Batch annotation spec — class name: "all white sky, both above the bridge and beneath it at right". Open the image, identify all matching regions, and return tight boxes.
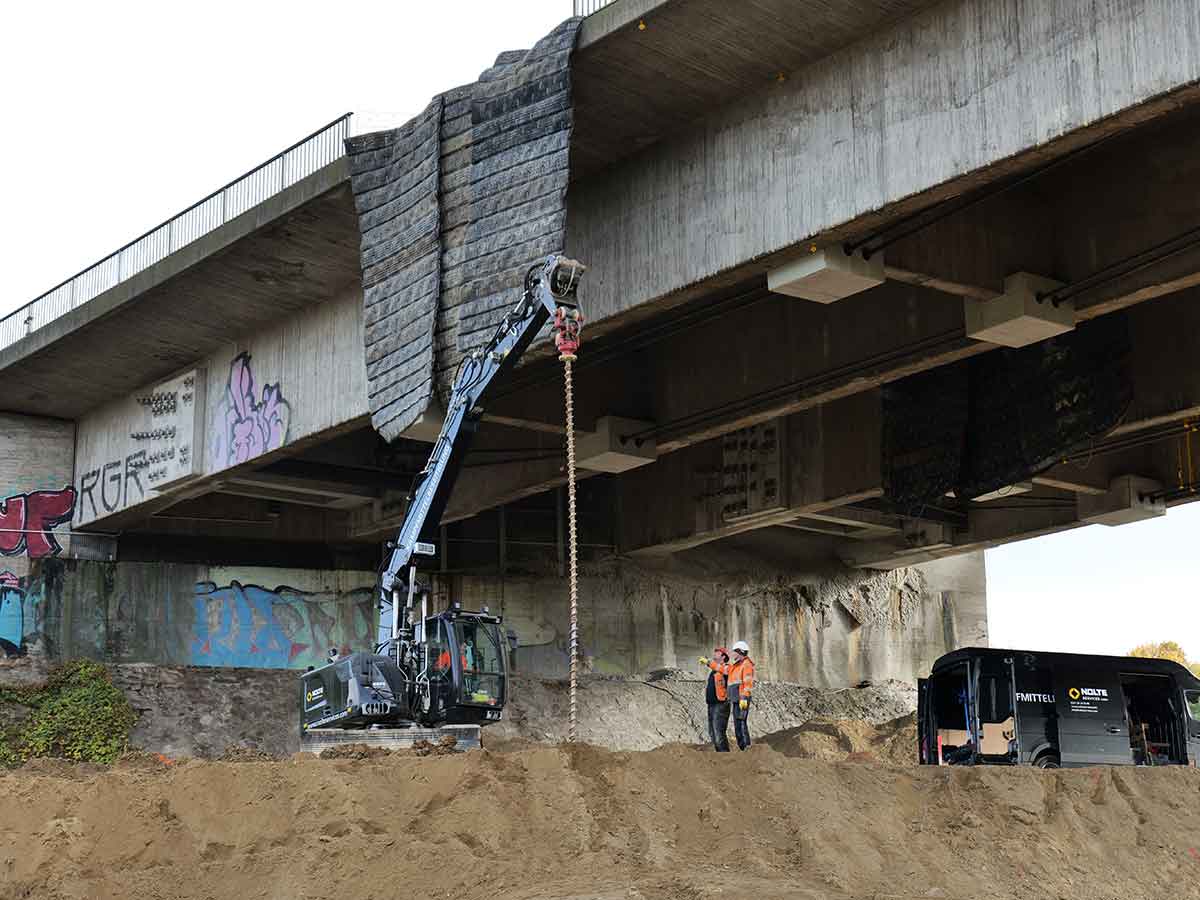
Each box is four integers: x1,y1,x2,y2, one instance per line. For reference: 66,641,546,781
0,0,1200,659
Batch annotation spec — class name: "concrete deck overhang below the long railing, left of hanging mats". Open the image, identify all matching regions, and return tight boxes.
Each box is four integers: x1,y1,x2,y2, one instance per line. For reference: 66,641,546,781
0,160,359,418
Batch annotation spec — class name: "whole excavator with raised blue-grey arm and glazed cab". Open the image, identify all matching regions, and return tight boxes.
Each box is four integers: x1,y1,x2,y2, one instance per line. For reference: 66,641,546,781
300,256,584,749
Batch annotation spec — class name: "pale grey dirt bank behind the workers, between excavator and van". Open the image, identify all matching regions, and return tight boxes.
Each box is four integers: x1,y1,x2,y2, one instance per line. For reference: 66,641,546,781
484,670,917,750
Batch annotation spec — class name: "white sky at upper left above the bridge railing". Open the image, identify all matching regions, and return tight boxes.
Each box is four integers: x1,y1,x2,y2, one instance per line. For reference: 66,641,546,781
0,0,561,313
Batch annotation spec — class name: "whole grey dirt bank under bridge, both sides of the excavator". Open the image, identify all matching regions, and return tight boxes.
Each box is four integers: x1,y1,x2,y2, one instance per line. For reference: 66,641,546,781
79,664,917,760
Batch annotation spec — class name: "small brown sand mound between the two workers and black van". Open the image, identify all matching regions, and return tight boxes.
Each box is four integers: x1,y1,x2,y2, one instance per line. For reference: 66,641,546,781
762,713,917,766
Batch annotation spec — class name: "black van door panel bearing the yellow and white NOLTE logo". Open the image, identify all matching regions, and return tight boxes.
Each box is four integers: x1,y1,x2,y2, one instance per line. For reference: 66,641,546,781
1055,666,1133,767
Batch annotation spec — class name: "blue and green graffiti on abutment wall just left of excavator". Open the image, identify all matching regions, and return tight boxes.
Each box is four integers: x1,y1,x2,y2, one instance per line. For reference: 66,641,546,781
188,581,377,668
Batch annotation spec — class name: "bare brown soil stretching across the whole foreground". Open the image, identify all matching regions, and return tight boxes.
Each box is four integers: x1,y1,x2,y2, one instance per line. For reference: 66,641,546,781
0,748,1200,900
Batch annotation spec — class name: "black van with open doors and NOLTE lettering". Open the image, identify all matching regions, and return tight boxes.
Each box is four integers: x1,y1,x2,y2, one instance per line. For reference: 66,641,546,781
917,647,1200,769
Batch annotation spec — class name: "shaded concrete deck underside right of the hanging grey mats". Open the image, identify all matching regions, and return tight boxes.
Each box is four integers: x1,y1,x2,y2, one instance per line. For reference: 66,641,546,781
571,0,935,178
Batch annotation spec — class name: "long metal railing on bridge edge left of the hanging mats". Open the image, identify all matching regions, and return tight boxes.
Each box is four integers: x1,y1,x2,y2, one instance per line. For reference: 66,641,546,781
0,113,352,349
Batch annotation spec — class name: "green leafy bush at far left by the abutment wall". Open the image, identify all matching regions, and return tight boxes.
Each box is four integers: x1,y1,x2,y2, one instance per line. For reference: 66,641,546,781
0,660,137,768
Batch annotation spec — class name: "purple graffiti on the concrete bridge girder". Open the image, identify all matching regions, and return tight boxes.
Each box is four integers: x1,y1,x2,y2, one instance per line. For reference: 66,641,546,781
216,353,292,466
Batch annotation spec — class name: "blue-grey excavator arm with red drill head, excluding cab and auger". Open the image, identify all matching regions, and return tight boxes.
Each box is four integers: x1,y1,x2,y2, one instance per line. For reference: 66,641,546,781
379,256,584,607
